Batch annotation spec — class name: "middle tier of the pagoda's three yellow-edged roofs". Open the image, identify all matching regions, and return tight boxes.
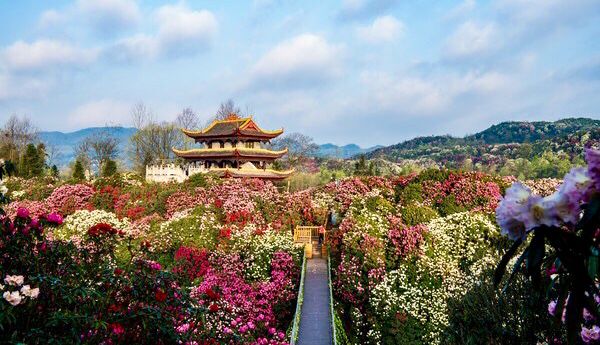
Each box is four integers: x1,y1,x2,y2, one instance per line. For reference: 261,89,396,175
173,147,288,160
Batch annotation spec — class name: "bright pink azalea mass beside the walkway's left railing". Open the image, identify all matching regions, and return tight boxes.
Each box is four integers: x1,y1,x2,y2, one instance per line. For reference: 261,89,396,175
192,253,298,344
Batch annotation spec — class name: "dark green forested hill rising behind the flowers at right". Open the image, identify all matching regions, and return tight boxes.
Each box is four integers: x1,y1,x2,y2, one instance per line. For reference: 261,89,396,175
367,118,600,166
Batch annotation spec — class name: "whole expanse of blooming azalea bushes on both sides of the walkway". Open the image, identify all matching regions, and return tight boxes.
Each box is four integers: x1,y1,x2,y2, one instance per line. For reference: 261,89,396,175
0,165,600,344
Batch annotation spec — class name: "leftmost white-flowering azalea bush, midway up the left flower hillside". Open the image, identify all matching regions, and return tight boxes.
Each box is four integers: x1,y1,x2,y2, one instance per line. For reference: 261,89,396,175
53,210,130,240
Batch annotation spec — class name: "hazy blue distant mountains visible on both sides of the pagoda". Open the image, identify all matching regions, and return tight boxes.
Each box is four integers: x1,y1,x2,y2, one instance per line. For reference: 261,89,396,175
39,127,382,166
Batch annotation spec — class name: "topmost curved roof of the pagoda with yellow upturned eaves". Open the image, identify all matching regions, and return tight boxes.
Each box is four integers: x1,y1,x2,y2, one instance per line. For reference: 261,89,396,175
182,114,283,142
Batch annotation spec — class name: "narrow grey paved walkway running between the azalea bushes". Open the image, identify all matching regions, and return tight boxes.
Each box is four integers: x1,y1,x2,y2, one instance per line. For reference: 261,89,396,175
297,256,333,345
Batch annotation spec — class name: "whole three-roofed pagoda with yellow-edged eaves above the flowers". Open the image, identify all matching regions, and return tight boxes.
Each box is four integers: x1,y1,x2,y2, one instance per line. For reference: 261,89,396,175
173,114,293,180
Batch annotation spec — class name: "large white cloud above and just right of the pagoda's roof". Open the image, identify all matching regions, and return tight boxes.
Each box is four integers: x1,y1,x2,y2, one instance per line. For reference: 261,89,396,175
250,34,342,86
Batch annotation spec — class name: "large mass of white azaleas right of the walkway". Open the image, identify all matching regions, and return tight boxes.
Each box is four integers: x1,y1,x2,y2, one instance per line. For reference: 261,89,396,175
370,212,500,344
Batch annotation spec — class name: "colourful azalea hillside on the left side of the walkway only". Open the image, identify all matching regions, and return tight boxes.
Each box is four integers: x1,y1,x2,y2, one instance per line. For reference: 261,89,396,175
0,175,312,344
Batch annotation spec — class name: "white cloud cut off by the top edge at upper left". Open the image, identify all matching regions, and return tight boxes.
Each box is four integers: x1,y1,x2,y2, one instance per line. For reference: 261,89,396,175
76,0,142,33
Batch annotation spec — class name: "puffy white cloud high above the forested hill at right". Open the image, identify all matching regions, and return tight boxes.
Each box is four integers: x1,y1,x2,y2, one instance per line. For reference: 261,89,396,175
445,21,501,59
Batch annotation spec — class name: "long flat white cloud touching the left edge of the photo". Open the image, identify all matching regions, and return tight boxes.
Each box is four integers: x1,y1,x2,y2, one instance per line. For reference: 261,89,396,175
1,40,97,71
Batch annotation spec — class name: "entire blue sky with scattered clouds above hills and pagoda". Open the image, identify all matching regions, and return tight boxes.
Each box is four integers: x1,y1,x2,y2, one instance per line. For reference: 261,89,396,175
0,0,600,146
